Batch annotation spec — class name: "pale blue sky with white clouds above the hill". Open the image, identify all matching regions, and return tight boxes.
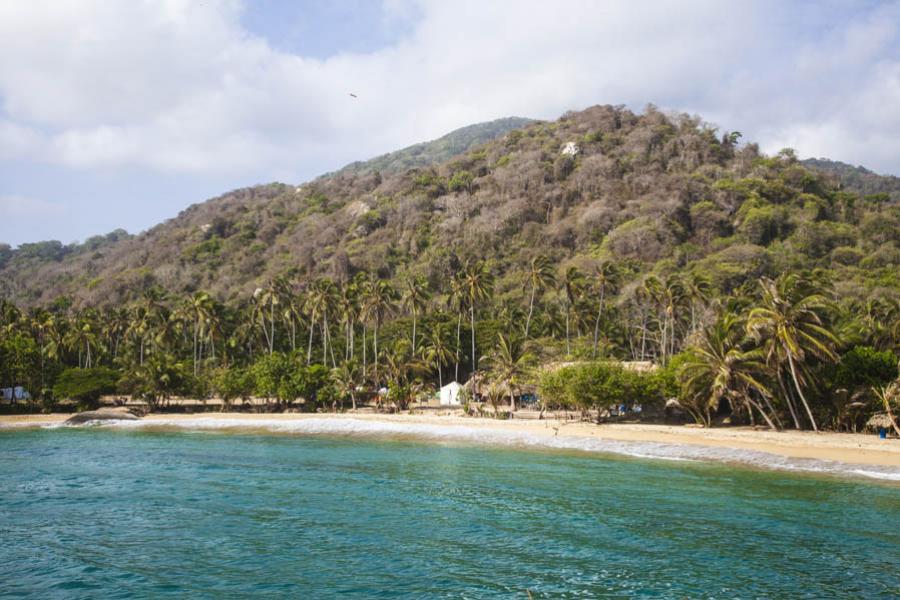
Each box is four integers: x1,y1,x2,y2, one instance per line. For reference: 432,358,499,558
0,0,900,246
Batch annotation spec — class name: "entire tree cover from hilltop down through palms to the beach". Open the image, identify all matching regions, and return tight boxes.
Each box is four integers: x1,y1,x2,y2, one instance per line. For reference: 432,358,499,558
0,106,900,430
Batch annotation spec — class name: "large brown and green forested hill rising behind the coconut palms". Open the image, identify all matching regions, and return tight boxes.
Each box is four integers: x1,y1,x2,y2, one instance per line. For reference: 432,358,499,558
0,106,900,306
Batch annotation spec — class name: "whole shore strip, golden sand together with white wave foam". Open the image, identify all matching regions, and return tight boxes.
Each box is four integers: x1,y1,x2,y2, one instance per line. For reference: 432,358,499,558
7,413,900,481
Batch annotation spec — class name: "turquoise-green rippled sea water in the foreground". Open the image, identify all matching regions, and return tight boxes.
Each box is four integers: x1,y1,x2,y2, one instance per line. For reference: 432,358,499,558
0,427,900,598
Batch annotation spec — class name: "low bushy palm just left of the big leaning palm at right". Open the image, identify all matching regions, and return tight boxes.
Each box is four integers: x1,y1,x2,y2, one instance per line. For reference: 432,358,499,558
679,313,781,429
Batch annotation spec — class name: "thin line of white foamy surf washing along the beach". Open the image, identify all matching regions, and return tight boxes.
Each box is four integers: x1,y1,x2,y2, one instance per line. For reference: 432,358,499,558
67,417,900,481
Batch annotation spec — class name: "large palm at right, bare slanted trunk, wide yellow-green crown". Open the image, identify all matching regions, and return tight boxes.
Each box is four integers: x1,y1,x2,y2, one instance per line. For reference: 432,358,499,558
747,273,838,431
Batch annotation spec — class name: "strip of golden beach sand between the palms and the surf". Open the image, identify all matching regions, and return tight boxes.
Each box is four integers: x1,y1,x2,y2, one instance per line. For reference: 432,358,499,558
7,413,900,472
